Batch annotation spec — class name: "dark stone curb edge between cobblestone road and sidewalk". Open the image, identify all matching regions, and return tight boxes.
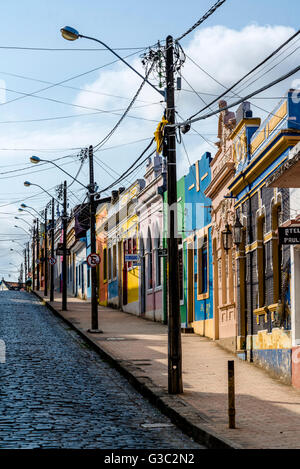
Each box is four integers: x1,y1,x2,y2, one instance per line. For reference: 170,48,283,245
31,291,243,449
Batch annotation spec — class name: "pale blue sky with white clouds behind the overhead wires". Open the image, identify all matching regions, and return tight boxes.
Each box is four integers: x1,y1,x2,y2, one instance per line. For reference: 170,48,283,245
0,0,300,279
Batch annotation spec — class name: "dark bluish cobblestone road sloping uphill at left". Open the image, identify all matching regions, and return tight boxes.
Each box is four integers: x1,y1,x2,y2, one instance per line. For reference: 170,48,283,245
0,291,201,449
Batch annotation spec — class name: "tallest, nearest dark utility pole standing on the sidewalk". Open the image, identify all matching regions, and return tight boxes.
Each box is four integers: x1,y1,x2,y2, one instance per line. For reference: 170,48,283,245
166,36,183,394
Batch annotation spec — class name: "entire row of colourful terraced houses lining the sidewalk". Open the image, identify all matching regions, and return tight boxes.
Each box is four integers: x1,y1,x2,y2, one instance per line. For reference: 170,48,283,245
36,90,300,387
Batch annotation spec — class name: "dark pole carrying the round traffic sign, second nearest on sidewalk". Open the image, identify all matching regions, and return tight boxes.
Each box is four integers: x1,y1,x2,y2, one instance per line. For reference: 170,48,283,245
89,145,102,333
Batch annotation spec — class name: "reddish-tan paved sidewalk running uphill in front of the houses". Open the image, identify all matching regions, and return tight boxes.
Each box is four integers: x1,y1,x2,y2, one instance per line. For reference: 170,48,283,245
34,292,300,448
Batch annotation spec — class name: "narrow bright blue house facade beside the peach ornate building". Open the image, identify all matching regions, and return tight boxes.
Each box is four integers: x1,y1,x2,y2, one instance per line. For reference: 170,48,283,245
183,152,213,338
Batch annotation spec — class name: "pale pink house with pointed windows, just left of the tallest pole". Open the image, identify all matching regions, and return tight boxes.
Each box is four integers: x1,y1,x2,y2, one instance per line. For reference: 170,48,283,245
136,155,166,322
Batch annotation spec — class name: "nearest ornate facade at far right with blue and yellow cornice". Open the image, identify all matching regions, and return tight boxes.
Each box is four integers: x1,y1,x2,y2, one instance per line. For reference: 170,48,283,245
229,91,300,383
